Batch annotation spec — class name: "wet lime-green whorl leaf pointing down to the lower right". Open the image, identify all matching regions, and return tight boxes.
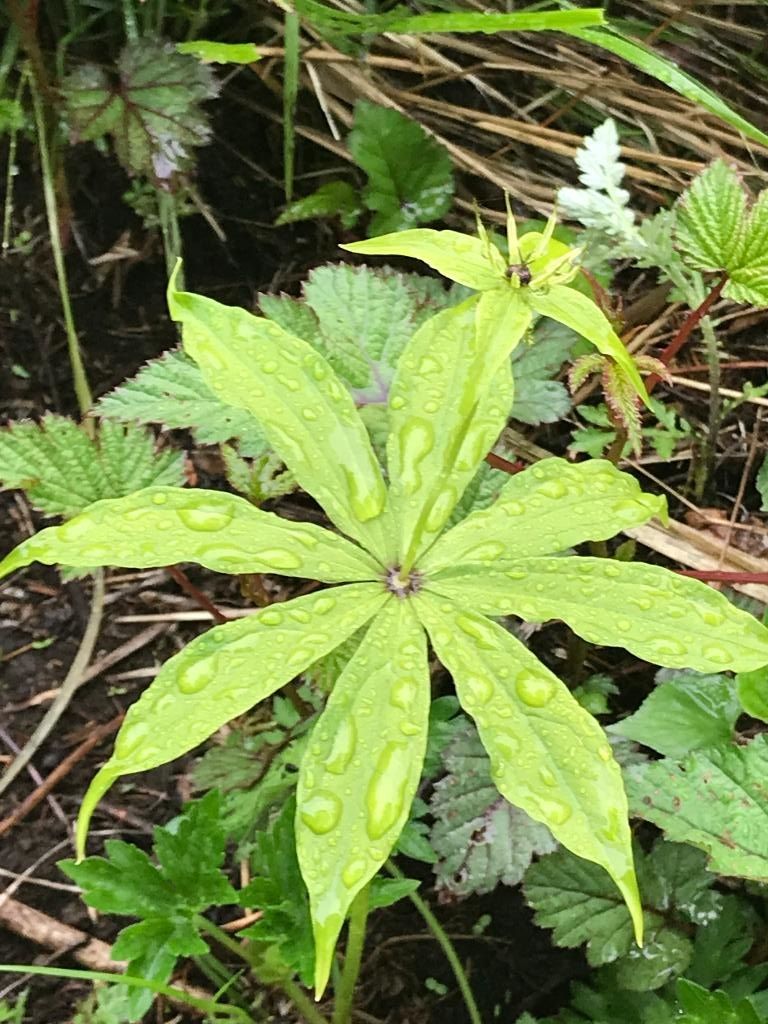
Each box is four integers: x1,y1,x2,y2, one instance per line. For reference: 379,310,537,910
414,592,642,941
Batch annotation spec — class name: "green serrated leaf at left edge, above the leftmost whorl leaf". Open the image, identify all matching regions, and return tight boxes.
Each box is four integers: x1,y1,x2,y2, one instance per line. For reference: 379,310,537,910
0,415,184,520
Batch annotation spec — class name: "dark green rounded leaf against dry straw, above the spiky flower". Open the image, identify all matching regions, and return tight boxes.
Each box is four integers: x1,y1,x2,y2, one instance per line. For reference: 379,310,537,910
347,100,454,236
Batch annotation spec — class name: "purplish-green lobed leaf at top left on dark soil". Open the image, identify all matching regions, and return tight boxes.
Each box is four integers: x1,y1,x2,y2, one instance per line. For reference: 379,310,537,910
61,38,218,182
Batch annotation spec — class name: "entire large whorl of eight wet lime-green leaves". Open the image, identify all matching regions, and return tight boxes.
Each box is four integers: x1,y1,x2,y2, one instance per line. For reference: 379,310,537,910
0,266,768,992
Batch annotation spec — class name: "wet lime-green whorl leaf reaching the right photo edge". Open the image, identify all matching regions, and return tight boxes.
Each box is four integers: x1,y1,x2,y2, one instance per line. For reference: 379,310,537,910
430,557,768,672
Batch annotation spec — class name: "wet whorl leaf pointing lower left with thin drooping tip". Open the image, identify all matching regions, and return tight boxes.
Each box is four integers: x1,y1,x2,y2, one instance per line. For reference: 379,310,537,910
77,584,387,856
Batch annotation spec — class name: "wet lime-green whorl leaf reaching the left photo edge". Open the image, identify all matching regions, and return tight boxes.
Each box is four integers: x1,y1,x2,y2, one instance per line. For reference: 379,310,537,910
0,487,381,583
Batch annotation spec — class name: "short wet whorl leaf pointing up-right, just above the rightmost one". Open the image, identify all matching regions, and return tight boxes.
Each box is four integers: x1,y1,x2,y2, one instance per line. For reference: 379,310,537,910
421,459,667,574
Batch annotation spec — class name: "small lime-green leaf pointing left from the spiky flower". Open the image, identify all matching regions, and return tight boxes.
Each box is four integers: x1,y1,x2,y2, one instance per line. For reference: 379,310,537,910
341,227,507,292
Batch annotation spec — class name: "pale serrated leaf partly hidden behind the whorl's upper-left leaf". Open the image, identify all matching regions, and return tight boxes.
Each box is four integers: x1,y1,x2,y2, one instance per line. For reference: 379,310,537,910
96,350,266,456
